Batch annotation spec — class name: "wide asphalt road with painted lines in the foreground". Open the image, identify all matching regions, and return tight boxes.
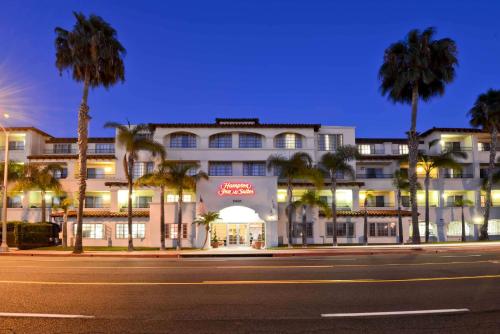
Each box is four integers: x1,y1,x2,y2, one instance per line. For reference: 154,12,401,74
0,252,500,334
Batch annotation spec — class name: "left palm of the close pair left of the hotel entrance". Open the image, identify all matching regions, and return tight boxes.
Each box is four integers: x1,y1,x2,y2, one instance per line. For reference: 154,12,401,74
135,156,170,250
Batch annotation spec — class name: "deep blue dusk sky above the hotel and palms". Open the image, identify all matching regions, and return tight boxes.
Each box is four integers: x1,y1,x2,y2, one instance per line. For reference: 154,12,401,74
0,0,500,137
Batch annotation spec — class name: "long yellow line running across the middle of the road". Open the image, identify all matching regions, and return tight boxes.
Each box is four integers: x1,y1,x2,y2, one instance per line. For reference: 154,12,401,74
0,274,500,286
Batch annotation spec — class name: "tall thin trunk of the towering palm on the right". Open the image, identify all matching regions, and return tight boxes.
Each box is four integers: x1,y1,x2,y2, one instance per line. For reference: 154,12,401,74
408,84,420,244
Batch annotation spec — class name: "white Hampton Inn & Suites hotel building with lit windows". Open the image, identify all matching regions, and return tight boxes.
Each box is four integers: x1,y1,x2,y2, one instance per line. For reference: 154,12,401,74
0,118,500,247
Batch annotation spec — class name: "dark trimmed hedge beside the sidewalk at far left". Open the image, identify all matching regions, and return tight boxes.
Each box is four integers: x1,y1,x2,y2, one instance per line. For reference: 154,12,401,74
0,222,59,249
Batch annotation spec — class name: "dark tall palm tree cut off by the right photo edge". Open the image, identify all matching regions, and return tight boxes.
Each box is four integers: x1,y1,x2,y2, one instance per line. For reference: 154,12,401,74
469,89,500,240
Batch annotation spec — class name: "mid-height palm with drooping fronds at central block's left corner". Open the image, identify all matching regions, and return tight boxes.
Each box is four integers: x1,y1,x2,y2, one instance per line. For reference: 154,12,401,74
104,122,165,252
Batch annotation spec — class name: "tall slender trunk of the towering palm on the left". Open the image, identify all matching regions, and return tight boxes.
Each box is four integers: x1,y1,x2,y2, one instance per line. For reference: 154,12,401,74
73,74,90,254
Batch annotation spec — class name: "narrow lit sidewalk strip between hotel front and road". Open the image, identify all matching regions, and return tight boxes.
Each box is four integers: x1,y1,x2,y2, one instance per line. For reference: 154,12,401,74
0,242,500,258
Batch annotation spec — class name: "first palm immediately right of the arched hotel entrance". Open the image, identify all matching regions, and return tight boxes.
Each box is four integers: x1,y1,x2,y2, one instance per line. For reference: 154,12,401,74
267,152,312,247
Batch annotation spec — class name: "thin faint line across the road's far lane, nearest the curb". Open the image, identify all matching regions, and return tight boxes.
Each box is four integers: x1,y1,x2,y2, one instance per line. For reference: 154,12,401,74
0,260,500,270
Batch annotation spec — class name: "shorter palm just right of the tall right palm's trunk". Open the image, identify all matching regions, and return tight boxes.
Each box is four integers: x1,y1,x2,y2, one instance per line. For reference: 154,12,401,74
418,140,467,243
